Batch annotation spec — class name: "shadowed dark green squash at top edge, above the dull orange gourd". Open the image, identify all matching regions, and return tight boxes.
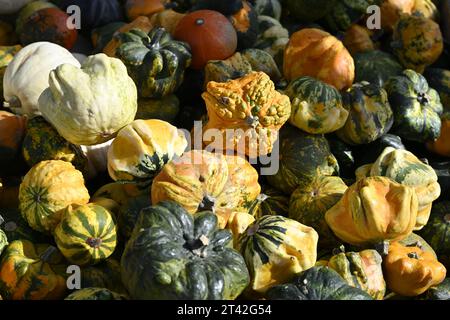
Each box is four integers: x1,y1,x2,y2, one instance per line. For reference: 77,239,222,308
325,0,382,32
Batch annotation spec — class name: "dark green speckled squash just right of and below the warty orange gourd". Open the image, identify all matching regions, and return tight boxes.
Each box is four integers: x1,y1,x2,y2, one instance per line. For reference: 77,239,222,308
267,125,339,195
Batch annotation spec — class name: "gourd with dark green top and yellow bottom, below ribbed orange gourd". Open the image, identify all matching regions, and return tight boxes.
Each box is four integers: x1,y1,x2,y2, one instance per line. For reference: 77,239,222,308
285,77,348,134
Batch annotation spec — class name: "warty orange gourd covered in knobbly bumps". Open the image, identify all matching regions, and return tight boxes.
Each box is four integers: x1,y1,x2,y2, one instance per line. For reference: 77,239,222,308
196,72,291,158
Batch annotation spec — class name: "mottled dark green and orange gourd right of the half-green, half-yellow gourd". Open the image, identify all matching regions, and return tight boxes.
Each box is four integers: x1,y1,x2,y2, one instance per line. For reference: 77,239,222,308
336,82,394,145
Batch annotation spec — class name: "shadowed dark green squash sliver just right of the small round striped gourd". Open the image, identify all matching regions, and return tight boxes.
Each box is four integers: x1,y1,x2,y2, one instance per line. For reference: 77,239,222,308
118,194,152,239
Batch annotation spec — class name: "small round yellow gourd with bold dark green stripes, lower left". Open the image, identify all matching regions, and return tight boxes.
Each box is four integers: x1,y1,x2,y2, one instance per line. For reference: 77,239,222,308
55,204,117,265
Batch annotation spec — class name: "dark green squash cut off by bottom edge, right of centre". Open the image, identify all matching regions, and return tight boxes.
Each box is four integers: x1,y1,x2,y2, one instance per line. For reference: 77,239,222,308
266,266,372,300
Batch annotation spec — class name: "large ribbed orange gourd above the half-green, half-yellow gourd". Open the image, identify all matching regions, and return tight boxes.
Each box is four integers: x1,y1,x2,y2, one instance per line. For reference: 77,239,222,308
283,28,355,90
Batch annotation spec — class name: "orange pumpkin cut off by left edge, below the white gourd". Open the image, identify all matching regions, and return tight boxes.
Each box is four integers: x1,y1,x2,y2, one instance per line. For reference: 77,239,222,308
0,111,27,162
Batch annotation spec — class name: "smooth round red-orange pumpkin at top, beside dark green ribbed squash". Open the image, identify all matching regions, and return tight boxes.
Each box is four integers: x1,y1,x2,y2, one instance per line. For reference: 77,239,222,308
174,10,238,70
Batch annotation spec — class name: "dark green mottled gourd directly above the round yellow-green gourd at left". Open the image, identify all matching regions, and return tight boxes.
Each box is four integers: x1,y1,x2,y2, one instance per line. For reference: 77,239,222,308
22,116,87,172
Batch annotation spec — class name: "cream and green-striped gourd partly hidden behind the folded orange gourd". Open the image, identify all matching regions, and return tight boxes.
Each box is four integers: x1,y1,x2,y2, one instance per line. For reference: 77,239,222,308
358,147,441,230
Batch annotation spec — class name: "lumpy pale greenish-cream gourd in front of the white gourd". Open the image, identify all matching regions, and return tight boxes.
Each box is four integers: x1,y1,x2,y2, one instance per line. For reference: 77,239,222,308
39,53,137,145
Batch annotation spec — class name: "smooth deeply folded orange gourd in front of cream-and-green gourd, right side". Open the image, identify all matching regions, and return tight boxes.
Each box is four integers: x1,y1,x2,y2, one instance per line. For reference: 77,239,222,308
325,177,418,246
